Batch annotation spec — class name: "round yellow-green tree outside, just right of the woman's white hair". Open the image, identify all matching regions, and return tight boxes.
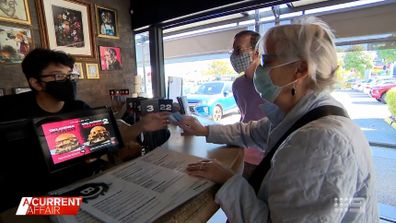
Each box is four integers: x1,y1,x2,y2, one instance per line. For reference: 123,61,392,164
344,46,374,78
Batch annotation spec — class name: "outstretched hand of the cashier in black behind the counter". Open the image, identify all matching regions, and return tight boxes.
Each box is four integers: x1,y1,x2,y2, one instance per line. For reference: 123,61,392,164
138,112,170,132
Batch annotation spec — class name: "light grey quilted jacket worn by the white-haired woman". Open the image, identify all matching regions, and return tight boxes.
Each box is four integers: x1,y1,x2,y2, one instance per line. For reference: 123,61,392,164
207,92,379,223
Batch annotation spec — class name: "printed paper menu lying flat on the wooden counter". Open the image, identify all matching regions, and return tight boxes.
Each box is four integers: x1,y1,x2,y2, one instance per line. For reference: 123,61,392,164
53,148,214,222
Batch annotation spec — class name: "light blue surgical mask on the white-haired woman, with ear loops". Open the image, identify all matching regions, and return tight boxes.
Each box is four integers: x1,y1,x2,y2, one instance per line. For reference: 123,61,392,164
253,60,298,102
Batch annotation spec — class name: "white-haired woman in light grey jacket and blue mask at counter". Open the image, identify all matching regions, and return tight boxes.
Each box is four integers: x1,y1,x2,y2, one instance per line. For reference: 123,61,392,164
178,17,379,223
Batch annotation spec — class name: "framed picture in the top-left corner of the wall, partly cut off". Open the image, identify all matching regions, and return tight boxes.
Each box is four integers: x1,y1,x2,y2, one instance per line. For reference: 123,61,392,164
0,0,30,25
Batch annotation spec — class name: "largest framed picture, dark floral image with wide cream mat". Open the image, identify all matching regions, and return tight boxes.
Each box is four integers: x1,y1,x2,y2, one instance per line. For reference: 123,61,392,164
38,0,95,58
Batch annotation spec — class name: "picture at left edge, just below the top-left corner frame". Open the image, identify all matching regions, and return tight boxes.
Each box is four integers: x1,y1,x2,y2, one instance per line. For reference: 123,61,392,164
0,25,33,64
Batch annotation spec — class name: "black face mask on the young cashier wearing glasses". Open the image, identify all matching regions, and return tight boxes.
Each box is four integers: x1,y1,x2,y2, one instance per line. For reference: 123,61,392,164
45,80,77,101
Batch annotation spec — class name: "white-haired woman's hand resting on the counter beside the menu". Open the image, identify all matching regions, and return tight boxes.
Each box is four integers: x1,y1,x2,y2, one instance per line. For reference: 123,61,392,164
187,160,234,184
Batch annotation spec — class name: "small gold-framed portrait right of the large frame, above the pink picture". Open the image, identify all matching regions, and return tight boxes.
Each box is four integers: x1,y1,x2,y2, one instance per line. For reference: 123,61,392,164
95,5,119,39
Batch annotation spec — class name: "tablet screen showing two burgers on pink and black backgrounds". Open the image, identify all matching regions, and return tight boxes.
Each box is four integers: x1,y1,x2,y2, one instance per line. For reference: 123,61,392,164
34,108,122,170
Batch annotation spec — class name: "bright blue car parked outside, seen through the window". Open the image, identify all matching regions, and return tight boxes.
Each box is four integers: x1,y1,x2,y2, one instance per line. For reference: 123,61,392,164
187,81,237,121
